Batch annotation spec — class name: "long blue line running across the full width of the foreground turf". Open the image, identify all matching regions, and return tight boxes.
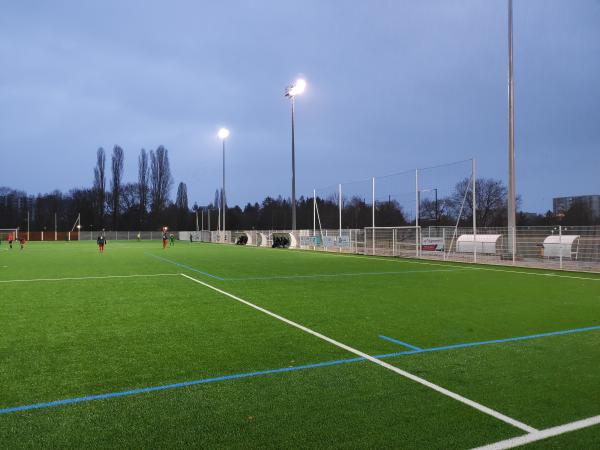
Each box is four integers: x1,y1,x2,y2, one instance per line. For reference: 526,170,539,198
0,325,600,414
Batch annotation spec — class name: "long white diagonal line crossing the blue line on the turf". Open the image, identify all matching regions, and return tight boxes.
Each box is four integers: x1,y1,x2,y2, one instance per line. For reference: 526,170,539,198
181,273,537,433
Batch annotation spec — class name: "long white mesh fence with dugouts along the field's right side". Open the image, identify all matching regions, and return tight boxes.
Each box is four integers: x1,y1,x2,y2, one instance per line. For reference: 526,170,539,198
182,226,600,272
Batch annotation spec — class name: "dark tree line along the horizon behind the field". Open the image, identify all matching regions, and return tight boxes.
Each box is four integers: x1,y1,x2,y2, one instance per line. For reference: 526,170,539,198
0,153,598,231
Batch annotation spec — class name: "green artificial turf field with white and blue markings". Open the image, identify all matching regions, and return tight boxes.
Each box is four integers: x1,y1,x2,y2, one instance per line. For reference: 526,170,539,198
0,241,600,449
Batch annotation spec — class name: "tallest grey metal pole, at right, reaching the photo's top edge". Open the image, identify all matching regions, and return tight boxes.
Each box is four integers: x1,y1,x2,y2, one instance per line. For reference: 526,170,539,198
507,0,517,256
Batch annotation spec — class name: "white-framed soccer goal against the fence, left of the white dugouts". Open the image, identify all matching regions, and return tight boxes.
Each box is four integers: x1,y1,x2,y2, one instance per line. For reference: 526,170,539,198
363,226,421,257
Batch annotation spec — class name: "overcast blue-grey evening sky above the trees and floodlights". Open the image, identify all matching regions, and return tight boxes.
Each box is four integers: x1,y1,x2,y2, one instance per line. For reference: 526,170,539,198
0,0,600,211
